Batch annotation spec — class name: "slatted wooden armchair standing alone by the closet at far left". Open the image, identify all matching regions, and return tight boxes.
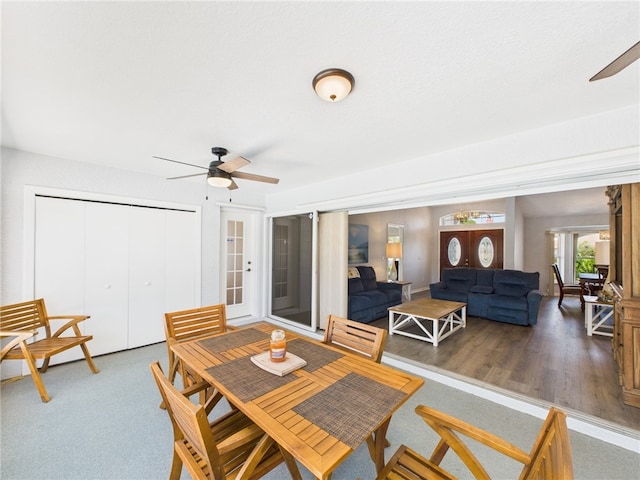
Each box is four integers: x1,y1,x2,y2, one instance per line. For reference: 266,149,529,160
0,298,98,402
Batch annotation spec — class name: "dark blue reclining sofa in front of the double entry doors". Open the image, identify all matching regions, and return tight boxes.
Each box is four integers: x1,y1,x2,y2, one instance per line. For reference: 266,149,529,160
430,267,542,325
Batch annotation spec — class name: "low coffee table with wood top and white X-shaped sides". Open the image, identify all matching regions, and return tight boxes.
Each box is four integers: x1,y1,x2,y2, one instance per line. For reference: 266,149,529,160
388,298,467,347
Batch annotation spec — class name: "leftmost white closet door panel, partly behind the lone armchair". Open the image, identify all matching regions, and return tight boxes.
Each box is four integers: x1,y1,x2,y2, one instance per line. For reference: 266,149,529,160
34,197,86,365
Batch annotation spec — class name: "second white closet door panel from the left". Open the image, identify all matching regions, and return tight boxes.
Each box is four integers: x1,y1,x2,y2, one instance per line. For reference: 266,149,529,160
85,203,130,355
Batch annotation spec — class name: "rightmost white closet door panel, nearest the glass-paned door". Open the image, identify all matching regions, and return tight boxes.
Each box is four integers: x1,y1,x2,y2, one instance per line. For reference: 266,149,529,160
165,210,200,312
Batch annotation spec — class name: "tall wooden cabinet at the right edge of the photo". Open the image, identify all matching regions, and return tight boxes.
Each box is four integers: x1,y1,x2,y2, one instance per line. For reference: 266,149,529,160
607,183,640,407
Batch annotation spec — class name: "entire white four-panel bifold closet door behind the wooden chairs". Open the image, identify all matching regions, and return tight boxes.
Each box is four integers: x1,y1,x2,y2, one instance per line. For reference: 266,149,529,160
35,197,200,364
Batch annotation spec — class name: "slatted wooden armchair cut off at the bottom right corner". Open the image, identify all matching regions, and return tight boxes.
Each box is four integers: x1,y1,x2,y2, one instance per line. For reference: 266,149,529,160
377,405,573,480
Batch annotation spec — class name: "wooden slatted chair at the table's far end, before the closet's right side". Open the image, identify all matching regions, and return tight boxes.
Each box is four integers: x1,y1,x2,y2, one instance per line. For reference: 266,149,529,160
160,304,232,413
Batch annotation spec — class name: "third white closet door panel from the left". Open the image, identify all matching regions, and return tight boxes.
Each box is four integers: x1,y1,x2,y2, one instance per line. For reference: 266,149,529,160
128,207,165,348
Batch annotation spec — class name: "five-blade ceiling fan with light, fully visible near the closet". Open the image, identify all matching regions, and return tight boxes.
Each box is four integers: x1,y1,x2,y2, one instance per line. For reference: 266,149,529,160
153,147,280,190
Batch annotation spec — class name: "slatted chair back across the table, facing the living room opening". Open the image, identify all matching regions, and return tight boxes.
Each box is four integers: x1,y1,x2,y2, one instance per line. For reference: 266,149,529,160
324,315,387,363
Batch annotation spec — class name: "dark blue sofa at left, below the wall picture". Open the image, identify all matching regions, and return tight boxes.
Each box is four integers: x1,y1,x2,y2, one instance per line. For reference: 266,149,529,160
347,266,402,323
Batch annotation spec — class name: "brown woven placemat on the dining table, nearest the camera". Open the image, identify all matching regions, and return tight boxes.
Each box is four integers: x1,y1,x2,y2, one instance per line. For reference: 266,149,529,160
293,373,405,449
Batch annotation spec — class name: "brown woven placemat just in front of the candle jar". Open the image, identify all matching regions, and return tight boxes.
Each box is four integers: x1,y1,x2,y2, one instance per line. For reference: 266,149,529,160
207,356,298,402
